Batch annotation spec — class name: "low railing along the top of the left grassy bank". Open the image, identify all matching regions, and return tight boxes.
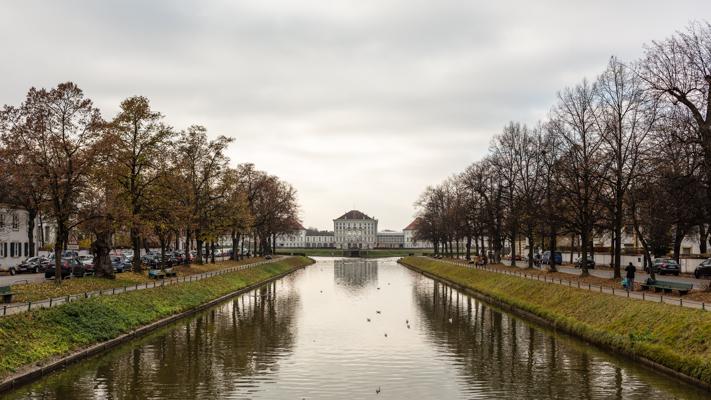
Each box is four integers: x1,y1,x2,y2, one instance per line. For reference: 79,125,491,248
0,256,282,317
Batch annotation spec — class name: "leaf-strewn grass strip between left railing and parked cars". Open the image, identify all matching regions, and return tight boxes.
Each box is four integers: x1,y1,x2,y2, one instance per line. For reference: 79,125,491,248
12,258,264,303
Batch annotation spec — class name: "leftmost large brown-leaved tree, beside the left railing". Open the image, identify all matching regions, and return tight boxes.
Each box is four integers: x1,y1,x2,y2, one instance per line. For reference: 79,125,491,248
2,82,104,284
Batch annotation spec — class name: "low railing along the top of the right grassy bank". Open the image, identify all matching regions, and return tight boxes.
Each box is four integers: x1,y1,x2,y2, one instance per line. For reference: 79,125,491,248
428,260,708,311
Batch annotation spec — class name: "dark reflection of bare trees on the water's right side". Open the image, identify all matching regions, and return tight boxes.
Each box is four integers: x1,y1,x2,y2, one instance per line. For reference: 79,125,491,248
414,279,696,399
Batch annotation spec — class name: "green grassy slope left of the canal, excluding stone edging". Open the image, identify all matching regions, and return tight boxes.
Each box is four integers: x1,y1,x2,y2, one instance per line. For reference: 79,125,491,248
0,257,311,380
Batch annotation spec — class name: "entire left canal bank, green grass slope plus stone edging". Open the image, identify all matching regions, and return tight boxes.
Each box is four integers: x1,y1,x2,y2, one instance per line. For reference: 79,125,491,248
0,257,314,393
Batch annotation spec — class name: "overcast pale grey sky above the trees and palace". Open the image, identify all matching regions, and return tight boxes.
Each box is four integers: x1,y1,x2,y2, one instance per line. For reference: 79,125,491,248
0,0,711,230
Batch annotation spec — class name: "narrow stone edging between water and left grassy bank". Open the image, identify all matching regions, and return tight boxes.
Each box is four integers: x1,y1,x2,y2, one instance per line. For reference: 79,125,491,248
0,257,315,394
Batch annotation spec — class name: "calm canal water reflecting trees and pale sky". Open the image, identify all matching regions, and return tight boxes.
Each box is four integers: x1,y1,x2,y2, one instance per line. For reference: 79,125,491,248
7,259,710,400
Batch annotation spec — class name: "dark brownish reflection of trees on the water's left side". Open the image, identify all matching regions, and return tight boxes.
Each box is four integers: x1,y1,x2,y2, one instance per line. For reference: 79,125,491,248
13,280,299,399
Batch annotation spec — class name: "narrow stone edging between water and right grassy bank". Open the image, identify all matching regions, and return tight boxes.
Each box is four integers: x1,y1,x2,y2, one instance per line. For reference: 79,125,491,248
398,259,711,392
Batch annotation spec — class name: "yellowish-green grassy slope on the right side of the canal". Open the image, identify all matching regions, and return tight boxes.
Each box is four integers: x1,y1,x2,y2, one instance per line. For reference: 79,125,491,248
402,257,711,385
